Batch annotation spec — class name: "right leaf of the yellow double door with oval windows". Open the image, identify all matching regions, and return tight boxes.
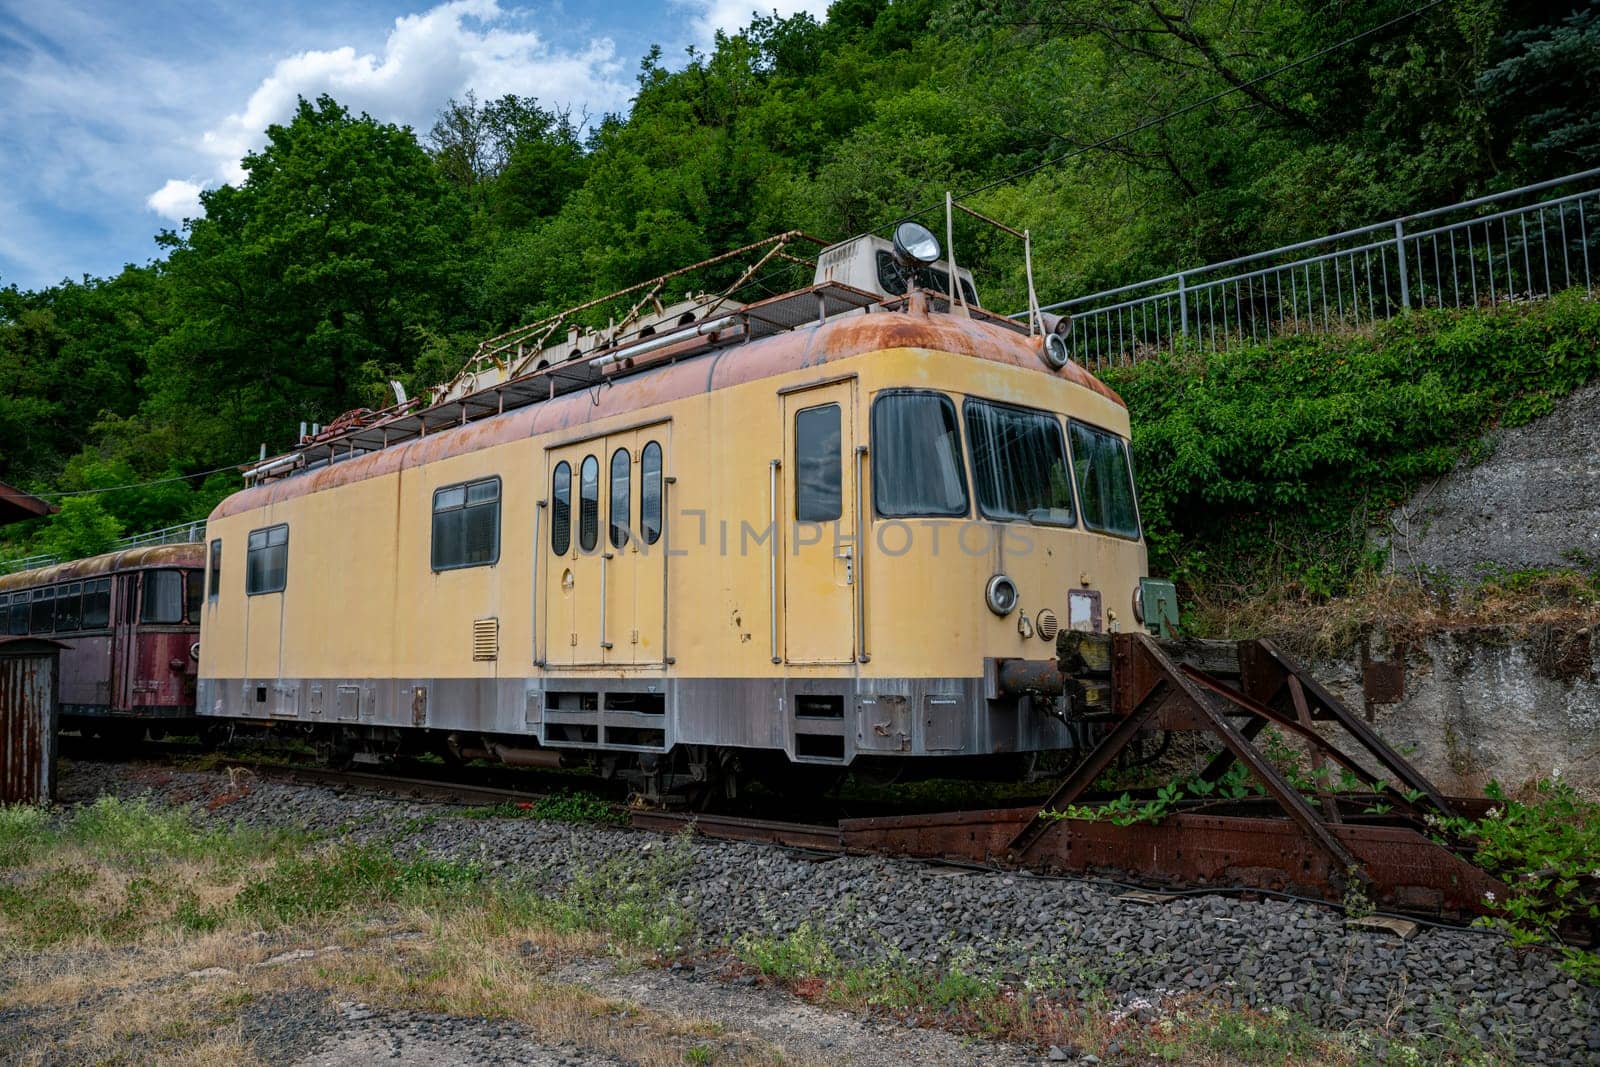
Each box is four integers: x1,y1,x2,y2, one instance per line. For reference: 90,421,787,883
602,424,667,665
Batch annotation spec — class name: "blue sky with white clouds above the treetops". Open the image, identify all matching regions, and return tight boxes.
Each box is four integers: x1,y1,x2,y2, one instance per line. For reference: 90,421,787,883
0,0,827,290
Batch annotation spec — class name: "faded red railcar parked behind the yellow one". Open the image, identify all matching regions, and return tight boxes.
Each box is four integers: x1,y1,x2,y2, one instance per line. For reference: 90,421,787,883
0,544,205,729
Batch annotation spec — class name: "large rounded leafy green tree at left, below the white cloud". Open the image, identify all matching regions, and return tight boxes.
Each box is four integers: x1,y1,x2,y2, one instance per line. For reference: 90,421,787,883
147,96,472,461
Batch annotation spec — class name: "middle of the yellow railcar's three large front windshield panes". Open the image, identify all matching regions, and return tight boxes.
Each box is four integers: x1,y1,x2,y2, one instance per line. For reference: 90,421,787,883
965,400,1075,526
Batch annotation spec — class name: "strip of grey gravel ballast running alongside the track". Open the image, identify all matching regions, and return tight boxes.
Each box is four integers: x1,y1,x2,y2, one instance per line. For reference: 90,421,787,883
64,765,1600,1064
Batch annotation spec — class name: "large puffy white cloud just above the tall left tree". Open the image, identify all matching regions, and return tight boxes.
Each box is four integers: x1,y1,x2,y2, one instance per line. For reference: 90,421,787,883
146,0,629,218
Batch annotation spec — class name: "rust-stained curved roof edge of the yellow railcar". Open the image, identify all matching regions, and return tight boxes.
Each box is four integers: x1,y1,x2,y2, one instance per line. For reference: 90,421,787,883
211,303,1126,518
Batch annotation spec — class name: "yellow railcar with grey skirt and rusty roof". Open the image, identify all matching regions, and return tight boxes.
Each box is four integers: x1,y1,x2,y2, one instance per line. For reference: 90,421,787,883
198,230,1146,792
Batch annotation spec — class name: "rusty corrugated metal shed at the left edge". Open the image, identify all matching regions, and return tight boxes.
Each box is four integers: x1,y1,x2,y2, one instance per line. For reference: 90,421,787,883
0,637,66,805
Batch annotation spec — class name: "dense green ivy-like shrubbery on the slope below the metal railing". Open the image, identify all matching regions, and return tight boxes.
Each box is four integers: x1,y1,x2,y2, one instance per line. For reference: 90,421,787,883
1106,291,1600,600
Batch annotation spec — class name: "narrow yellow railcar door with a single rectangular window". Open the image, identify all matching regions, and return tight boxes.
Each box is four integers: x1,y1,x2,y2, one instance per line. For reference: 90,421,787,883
774,381,859,664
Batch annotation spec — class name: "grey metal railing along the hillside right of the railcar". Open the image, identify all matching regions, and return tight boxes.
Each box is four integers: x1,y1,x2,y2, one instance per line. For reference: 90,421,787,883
1045,168,1600,368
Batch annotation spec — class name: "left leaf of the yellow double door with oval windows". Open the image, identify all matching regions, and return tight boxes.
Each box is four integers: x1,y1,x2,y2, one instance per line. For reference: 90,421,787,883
544,440,610,667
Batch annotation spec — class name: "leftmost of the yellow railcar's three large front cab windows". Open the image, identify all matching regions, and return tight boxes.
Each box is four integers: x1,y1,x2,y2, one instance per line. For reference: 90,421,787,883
872,392,966,518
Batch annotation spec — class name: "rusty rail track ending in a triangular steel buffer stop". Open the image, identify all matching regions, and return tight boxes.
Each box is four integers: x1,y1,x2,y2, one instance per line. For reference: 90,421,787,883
53,632,1561,936
